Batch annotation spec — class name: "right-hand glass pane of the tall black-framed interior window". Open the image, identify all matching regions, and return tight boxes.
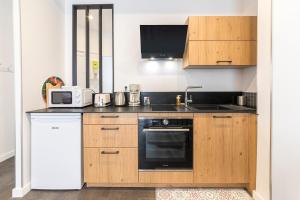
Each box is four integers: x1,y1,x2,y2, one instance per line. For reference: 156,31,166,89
102,9,113,93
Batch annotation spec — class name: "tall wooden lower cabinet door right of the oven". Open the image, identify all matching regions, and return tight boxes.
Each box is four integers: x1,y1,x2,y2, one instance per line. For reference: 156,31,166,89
194,114,248,183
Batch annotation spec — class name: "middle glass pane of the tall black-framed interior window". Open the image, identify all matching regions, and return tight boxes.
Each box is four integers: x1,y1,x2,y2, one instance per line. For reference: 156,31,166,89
88,9,100,93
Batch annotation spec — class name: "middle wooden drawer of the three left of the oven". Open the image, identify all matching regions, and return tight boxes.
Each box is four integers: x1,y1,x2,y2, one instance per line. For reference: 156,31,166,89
83,125,138,147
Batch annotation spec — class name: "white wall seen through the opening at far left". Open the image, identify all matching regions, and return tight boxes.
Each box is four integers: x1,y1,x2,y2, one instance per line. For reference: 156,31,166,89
0,0,15,162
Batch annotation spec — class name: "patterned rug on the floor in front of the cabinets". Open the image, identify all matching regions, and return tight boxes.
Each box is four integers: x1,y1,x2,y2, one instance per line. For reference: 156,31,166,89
155,188,252,200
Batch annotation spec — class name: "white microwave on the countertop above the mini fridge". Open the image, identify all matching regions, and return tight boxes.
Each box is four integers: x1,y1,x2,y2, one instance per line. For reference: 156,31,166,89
47,86,93,108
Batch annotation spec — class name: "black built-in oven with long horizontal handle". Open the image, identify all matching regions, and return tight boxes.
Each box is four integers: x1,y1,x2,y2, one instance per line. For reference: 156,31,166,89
139,118,193,170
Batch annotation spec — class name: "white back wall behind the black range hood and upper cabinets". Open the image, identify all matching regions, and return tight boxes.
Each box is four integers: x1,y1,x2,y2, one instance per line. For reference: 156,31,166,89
66,0,257,91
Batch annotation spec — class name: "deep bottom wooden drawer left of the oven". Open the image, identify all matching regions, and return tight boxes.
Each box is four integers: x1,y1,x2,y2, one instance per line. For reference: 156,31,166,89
84,148,138,183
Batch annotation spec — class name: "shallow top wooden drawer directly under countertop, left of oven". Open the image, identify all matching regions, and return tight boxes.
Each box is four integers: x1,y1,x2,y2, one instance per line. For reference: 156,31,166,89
83,113,137,124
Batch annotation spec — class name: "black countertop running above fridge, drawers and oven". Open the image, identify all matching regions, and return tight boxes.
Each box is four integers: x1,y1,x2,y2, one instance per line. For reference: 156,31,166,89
27,104,256,114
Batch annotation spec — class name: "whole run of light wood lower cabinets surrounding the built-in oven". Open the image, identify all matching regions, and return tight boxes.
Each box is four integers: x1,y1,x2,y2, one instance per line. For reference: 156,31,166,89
84,113,256,192
